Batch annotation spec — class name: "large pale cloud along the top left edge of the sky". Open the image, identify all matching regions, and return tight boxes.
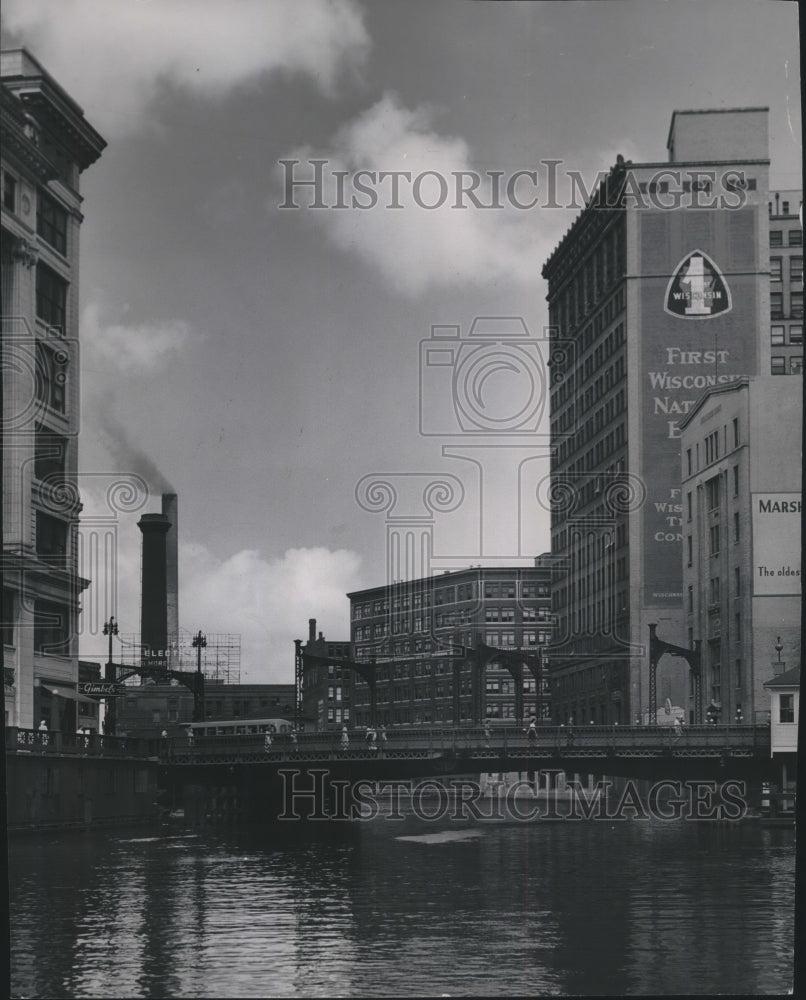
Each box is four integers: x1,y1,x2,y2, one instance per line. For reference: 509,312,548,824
3,0,369,135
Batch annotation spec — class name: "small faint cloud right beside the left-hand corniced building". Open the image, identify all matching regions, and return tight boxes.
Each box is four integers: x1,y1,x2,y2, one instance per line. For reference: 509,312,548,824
81,303,193,375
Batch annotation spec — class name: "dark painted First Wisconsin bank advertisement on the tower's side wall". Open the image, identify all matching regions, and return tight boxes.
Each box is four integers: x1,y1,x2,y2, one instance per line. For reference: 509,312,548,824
631,207,764,607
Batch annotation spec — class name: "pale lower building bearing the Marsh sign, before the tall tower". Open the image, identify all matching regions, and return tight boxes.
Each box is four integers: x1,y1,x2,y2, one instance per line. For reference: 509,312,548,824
681,375,803,723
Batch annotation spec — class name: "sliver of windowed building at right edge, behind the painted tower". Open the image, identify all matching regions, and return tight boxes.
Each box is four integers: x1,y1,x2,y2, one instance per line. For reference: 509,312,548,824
768,191,803,375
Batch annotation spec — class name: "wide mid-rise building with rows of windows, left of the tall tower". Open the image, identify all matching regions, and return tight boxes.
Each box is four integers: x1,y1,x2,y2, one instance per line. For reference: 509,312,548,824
348,556,552,726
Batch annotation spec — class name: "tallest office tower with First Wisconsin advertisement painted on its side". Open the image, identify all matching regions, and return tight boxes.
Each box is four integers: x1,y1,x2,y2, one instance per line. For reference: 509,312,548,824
543,108,770,723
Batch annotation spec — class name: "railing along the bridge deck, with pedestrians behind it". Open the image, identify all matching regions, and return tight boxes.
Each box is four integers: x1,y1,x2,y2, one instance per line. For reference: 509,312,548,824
160,725,769,763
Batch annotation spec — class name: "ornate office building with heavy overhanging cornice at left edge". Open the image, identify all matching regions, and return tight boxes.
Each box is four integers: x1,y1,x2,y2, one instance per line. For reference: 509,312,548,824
0,49,106,731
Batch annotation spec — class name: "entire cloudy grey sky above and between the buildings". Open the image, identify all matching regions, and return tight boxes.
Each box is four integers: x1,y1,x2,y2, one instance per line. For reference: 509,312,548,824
2,0,802,683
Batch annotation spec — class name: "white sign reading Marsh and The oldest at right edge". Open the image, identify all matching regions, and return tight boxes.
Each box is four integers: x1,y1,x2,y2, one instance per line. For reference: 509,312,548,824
752,493,801,597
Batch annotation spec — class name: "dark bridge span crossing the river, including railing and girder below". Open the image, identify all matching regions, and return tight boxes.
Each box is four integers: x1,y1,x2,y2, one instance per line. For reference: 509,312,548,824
160,725,770,784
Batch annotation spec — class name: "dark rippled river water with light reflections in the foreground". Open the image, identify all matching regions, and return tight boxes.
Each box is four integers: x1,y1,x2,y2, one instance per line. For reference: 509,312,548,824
9,817,794,997
